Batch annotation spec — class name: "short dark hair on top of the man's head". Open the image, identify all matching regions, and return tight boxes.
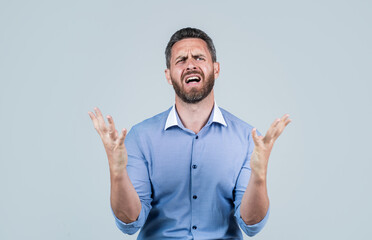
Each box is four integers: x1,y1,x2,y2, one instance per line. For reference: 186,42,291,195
165,27,217,68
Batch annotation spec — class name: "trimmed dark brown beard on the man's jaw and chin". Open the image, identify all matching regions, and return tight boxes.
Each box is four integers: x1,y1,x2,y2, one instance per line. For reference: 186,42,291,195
171,69,215,103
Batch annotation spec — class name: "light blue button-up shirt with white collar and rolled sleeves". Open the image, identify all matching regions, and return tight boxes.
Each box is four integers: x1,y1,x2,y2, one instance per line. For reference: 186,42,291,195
114,103,269,240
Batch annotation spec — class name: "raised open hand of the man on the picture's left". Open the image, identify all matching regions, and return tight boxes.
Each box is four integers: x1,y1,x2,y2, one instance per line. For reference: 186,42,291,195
88,107,128,174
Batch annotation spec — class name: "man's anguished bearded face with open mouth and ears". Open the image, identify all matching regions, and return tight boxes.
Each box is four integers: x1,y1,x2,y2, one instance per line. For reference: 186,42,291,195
165,38,219,103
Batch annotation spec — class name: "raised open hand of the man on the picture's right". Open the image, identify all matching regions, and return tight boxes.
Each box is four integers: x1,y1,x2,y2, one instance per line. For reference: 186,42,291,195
250,114,291,179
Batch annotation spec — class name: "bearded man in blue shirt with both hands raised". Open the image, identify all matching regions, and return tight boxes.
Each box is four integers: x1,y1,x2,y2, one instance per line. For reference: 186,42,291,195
89,28,291,239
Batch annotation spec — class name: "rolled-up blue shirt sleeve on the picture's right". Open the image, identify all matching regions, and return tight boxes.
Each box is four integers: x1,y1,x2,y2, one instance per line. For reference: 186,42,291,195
234,128,270,237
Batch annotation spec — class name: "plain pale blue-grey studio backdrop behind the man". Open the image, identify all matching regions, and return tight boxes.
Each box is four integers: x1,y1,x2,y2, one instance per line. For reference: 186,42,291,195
0,0,372,240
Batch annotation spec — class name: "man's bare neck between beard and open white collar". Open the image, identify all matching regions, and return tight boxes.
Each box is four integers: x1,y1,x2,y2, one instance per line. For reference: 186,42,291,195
176,90,214,134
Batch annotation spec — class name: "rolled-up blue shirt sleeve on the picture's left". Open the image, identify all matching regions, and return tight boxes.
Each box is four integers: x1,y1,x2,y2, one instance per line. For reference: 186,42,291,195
111,127,152,235
